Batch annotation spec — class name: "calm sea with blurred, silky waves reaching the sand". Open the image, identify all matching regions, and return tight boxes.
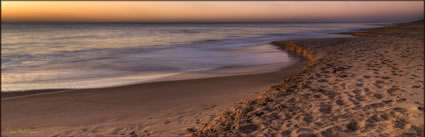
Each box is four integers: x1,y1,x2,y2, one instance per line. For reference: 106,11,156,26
1,23,388,92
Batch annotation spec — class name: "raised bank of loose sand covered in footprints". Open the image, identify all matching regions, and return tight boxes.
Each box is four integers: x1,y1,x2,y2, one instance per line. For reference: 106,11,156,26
192,21,424,137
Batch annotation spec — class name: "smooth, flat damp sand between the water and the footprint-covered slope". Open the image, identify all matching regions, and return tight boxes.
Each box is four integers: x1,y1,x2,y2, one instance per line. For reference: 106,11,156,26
1,57,308,137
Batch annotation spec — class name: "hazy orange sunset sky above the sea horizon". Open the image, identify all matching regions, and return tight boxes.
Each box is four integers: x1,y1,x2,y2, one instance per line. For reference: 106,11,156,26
1,1,424,22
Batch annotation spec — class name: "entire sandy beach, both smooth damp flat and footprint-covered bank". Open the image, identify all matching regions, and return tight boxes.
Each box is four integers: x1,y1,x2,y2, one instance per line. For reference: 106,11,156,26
1,21,424,137
